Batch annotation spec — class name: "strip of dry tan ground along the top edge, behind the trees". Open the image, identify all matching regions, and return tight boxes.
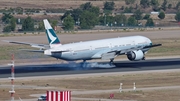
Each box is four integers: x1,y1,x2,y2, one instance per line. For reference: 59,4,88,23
0,0,179,9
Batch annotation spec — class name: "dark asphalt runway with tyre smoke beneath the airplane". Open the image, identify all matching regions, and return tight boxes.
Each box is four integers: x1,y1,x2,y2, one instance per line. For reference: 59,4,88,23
0,58,180,78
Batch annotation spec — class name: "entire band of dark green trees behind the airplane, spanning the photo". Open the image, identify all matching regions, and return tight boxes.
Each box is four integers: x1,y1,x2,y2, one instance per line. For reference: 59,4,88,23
2,2,180,32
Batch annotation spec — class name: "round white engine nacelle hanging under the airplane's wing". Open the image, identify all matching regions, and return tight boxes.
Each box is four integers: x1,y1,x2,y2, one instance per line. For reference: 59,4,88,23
127,50,144,61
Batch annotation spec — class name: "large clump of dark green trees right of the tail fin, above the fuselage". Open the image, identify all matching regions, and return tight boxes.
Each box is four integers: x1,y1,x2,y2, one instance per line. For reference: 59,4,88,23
61,2,171,30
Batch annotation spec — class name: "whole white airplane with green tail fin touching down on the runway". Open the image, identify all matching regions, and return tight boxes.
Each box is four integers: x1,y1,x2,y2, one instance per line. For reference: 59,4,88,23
3,19,162,64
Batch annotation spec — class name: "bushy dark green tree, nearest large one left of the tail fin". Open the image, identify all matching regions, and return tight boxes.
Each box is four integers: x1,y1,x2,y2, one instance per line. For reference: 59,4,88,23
22,16,34,31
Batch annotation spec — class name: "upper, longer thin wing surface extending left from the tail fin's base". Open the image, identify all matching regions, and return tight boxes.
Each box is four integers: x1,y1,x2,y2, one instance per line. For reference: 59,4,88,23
3,40,50,49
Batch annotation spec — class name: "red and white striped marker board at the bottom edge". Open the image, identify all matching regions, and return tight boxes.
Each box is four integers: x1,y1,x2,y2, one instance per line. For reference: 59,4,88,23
46,91,71,101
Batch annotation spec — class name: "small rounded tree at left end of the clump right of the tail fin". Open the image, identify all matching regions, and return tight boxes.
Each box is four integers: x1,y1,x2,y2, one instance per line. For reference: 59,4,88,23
63,15,74,30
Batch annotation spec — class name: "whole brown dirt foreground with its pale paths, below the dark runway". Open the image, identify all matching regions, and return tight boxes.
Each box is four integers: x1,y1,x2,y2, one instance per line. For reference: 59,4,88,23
0,70,180,101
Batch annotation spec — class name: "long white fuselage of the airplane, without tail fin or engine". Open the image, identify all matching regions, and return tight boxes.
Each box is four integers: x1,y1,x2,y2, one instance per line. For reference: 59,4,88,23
44,36,152,61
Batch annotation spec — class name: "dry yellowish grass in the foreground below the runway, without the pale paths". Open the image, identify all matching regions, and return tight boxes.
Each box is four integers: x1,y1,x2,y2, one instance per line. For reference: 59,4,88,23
0,72,180,101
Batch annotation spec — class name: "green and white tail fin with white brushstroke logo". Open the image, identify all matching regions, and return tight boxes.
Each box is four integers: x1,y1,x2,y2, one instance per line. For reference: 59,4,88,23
43,19,60,47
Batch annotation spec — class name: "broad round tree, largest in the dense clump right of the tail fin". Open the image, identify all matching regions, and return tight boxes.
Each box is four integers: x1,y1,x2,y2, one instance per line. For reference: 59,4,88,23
80,10,98,29
